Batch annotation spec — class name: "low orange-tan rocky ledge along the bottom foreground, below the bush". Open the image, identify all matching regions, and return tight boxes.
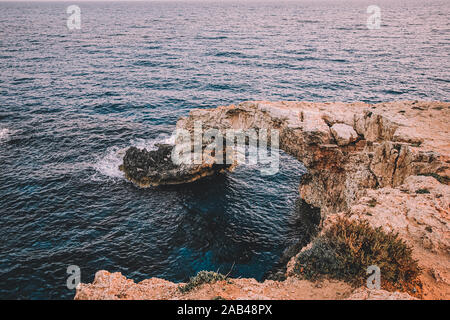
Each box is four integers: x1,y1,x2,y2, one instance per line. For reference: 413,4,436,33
75,271,415,300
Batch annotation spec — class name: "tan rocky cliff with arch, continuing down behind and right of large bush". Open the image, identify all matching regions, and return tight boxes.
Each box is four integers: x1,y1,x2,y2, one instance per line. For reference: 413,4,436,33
76,101,450,298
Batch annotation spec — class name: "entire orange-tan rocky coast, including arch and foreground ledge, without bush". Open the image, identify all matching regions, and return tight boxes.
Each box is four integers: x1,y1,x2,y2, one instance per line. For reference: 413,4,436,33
75,101,450,299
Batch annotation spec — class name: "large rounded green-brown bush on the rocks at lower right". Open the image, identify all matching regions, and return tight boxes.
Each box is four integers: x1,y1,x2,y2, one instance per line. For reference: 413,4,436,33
294,217,421,295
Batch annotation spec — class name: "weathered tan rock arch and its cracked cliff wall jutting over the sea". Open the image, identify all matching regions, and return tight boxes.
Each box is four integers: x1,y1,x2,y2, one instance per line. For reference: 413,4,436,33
177,102,450,216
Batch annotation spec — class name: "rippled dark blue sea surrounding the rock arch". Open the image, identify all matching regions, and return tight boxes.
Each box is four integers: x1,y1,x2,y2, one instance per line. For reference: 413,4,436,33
0,0,450,299
